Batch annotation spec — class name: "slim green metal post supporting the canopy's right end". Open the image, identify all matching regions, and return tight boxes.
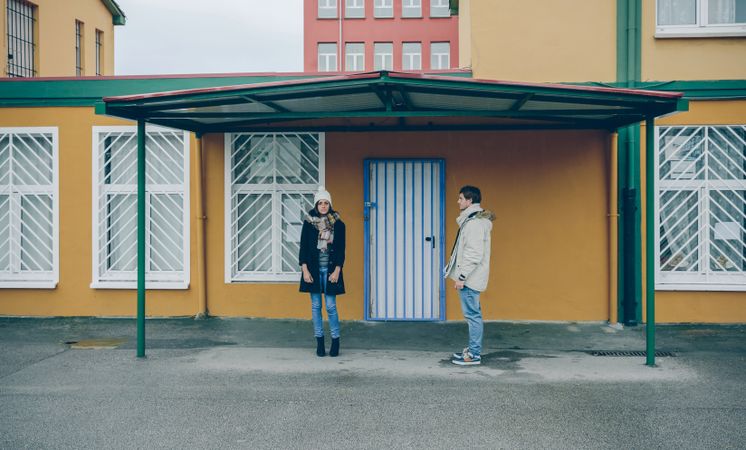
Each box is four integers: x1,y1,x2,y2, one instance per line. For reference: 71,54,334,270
645,117,656,366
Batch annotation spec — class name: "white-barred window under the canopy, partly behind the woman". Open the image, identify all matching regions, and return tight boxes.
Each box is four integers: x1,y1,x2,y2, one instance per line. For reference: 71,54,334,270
225,133,324,283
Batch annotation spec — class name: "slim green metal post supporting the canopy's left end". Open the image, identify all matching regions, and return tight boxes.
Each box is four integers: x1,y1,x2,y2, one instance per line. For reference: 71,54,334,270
137,120,145,358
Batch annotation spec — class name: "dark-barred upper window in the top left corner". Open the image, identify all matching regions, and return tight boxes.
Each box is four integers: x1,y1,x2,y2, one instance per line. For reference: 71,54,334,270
6,0,36,77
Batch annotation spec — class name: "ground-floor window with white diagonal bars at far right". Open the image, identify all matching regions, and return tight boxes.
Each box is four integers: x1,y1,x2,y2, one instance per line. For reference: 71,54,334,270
656,125,746,291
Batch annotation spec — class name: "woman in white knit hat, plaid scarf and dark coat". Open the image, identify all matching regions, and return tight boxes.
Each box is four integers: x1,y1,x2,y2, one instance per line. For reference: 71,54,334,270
298,186,345,356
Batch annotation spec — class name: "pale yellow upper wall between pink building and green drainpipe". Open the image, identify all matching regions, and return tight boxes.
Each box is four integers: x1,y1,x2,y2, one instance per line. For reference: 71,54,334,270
459,0,616,81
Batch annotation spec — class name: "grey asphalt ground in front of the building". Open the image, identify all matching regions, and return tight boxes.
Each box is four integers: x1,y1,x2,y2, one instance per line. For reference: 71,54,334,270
0,318,746,449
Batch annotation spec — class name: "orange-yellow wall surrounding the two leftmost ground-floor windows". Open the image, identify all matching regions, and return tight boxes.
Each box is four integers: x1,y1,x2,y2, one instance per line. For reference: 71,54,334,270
0,108,197,316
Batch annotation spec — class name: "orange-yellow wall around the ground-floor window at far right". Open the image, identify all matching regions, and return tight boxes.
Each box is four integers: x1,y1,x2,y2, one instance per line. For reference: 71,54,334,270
640,100,746,323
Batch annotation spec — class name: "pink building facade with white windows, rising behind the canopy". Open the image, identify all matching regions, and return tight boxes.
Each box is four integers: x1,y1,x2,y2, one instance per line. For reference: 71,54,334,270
303,0,458,72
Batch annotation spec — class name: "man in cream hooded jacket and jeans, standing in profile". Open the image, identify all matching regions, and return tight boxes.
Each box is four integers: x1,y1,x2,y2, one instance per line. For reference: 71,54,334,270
444,186,495,366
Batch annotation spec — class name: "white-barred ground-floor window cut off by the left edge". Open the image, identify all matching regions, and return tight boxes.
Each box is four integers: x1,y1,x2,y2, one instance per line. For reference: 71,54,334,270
0,128,60,288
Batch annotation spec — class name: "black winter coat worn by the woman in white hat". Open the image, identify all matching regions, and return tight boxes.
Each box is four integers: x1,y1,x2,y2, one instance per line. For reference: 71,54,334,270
298,209,345,295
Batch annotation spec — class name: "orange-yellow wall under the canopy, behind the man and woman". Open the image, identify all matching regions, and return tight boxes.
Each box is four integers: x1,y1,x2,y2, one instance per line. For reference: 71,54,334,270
199,128,608,320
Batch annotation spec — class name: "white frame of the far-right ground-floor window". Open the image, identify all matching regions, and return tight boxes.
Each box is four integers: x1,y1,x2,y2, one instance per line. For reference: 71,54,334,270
654,124,746,292
